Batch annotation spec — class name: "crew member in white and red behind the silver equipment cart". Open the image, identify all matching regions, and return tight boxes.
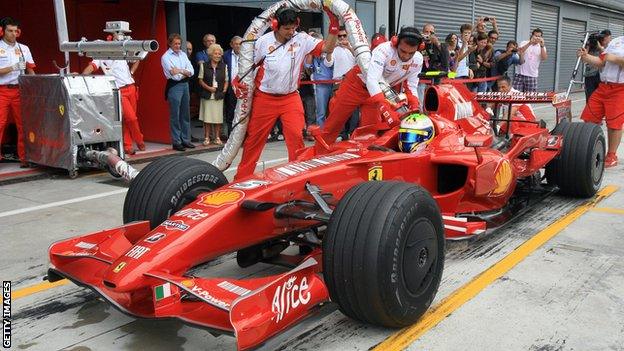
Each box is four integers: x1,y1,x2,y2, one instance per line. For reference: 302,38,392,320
82,26,145,155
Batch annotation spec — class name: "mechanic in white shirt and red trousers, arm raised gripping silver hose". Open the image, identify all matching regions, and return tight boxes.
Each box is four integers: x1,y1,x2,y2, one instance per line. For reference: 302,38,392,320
232,8,339,179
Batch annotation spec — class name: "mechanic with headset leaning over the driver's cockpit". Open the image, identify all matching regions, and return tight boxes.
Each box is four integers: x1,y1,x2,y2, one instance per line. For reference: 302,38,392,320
323,27,423,144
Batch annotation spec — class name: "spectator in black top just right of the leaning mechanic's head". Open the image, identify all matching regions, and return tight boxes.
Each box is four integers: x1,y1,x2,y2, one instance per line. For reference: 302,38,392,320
418,23,449,103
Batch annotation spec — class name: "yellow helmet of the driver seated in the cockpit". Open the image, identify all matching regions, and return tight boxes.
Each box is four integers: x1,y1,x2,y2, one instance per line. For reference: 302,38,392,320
399,113,435,153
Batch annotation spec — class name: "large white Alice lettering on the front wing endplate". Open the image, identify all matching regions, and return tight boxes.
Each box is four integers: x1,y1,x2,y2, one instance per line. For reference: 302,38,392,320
271,276,311,323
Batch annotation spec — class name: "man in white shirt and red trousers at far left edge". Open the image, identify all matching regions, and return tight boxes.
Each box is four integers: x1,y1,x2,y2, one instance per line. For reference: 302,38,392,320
0,17,35,168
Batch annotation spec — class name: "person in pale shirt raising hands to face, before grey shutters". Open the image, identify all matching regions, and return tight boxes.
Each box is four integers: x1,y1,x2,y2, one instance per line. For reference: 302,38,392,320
513,28,548,92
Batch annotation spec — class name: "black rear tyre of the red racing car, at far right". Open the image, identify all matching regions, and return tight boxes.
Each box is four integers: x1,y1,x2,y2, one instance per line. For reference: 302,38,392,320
546,121,605,198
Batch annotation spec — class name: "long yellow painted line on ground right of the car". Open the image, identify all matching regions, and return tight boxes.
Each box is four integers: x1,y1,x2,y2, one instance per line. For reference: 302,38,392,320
373,185,618,351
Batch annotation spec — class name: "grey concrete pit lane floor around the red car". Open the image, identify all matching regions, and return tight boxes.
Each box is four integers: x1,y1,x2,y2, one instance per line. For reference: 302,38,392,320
0,95,624,350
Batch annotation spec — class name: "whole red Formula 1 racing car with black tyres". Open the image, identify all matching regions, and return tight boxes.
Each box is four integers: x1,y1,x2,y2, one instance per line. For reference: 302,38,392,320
48,76,605,349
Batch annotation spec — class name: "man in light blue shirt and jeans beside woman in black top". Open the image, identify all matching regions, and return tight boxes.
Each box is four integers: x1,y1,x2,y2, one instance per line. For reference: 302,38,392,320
160,33,195,151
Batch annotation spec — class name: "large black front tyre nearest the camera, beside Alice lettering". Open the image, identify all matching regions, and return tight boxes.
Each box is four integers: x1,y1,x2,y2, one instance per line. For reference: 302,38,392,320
323,182,444,328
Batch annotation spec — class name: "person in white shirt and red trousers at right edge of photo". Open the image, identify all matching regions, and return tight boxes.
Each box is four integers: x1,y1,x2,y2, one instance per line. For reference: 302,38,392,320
577,36,624,167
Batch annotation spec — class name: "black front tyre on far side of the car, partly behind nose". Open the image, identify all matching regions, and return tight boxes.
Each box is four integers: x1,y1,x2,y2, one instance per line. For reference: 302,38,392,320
123,156,227,229
